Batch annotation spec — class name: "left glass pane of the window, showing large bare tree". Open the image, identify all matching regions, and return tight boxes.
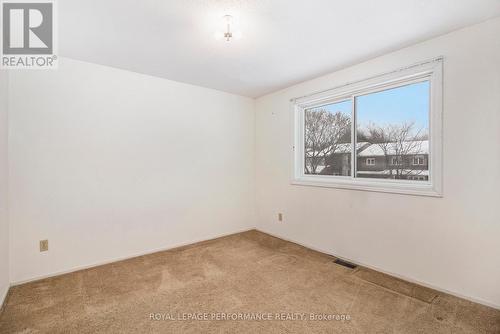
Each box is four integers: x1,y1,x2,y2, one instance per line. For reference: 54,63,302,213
304,100,352,176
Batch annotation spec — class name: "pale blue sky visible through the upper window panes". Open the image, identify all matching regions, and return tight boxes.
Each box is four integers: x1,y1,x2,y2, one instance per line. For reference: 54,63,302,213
322,81,430,129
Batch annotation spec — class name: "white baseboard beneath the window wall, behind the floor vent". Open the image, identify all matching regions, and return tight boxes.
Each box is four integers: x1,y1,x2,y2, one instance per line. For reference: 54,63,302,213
256,228,500,310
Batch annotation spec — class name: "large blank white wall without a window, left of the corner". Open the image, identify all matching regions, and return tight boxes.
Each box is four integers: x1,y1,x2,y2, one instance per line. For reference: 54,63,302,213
9,59,255,282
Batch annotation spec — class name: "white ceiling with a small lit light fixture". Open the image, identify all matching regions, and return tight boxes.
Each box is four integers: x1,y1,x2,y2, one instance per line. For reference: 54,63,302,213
58,0,500,97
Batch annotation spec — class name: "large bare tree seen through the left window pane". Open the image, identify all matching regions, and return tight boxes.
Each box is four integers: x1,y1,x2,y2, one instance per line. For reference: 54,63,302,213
305,109,351,174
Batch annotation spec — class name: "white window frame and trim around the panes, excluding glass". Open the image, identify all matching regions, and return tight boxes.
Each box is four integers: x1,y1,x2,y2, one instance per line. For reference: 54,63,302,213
291,57,443,197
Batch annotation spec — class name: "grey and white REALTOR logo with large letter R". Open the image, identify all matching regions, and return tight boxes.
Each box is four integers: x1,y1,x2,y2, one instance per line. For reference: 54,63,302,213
1,0,57,69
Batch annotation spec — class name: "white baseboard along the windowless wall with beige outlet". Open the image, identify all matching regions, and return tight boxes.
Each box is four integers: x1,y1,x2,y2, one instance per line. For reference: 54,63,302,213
11,227,255,286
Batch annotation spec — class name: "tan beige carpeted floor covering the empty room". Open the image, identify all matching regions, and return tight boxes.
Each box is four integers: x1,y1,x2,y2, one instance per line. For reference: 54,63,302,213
0,231,500,334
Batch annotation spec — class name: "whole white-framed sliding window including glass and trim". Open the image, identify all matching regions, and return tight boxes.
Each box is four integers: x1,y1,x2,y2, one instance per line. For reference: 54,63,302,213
292,58,442,196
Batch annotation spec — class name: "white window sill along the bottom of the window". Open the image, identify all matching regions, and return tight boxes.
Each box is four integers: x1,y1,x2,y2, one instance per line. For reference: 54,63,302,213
291,175,443,197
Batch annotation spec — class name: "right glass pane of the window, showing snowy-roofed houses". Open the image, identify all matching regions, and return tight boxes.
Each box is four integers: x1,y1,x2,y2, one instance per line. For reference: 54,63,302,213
356,81,430,181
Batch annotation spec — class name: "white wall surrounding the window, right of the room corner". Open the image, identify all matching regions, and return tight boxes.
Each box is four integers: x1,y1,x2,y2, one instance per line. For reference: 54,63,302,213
256,19,500,307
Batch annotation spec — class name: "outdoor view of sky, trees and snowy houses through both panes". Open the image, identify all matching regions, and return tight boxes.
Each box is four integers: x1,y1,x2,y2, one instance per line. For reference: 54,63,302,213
304,81,430,181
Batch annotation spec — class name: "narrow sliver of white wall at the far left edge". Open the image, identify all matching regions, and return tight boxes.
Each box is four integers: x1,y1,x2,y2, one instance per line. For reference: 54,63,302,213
0,70,10,307
